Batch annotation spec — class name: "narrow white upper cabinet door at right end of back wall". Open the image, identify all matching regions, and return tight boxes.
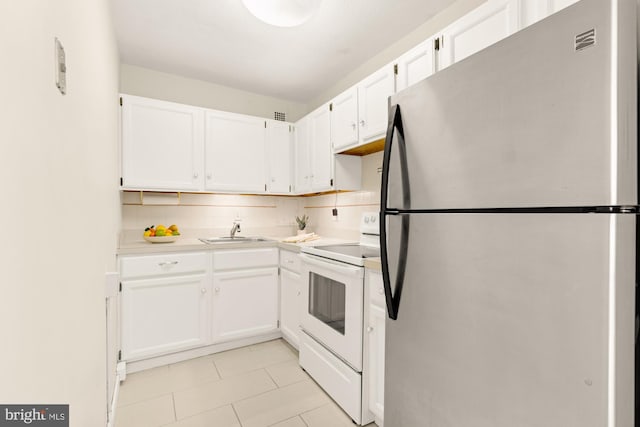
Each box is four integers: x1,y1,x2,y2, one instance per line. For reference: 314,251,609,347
267,120,292,194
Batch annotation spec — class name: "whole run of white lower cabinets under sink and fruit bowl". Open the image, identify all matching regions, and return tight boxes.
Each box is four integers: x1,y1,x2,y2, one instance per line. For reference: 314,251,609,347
119,247,279,366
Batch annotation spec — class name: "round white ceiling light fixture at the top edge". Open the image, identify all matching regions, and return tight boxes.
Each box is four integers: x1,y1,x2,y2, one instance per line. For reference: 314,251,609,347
242,0,322,27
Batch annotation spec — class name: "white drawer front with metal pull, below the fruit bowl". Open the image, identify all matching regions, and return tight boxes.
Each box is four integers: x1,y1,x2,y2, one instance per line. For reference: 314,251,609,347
120,252,208,279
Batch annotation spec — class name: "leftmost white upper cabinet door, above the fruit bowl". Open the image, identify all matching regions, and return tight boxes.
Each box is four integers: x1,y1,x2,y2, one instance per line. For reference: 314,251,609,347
122,95,204,191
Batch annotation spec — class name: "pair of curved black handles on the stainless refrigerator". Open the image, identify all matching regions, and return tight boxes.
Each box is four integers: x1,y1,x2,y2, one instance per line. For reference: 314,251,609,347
380,104,411,320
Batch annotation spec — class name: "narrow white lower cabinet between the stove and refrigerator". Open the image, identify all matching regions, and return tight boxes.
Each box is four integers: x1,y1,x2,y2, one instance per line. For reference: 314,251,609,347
364,270,387,427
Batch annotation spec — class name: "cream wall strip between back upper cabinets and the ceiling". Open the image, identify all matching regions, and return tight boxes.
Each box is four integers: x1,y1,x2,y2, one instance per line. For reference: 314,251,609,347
120,64,307,122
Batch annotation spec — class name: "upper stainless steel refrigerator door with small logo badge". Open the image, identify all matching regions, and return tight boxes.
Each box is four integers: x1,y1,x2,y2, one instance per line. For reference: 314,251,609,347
386,0,637,209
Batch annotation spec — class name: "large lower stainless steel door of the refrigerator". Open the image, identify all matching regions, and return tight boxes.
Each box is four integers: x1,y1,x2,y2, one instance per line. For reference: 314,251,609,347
384,213,635,427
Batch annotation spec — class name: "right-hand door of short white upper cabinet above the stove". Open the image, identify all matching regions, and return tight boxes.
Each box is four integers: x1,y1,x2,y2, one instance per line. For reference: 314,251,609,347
358,64,395,144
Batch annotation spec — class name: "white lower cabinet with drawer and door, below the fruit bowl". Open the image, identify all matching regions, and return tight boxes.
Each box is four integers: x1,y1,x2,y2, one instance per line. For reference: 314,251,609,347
121,253,211,360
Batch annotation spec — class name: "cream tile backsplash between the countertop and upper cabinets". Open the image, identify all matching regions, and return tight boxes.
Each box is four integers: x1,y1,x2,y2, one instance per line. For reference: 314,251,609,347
121,153,382,240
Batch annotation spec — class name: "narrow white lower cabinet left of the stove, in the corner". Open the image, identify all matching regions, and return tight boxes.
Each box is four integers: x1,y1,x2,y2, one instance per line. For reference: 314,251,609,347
280,250,302,349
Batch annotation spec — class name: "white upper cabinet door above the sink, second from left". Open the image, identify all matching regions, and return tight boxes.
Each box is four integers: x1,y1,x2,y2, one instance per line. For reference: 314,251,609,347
205,110,266,193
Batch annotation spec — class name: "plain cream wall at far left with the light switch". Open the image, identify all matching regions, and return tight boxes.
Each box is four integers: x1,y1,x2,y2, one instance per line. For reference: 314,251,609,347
0,0,119,427
